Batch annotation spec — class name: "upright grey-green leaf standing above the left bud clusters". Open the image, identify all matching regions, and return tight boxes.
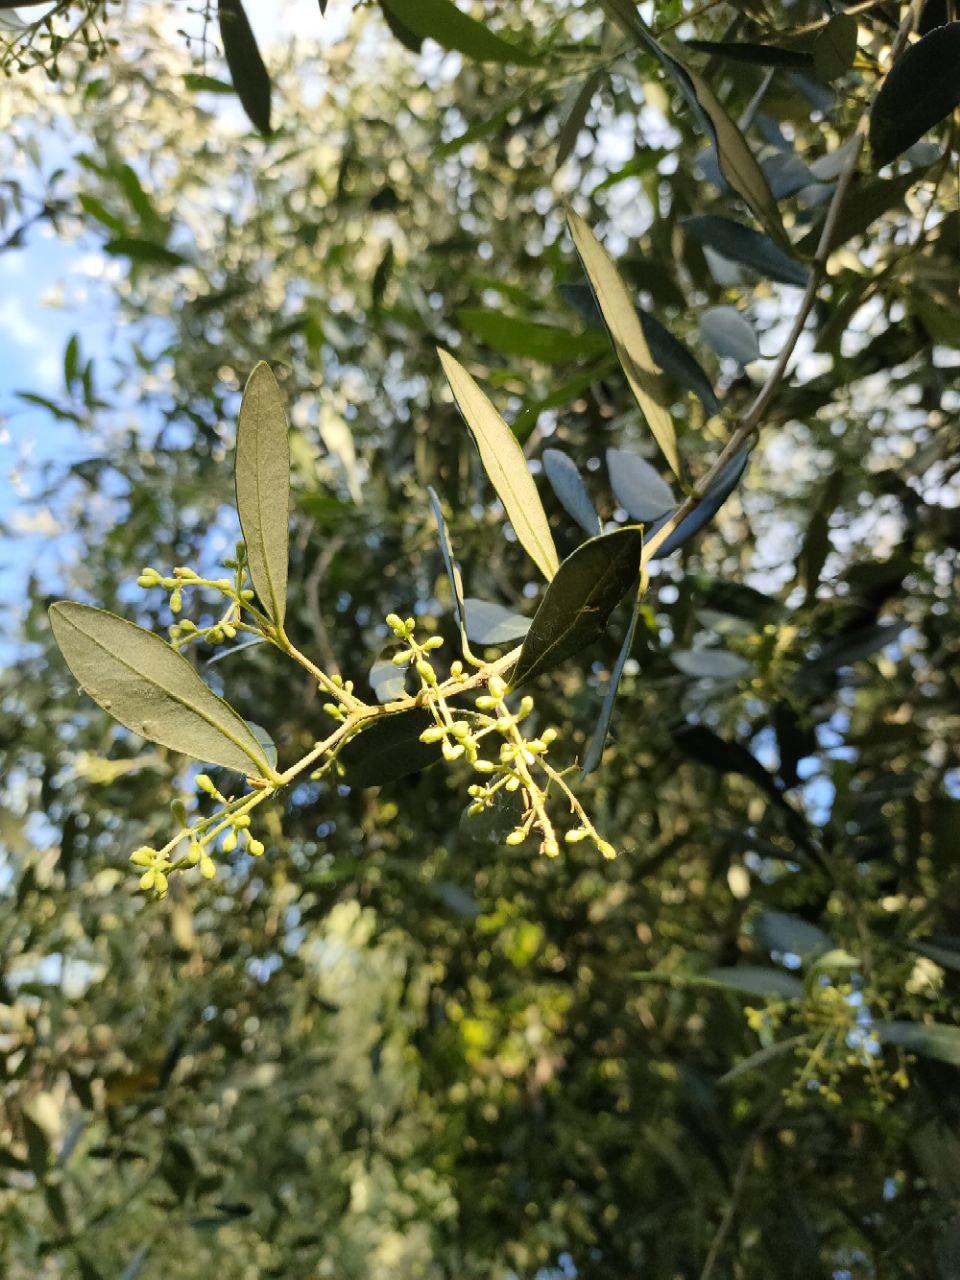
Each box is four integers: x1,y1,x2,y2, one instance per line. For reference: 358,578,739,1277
236,361,291,628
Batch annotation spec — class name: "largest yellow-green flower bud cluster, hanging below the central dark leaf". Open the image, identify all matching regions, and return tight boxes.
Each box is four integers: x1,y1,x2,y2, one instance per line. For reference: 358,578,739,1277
387,613,616,858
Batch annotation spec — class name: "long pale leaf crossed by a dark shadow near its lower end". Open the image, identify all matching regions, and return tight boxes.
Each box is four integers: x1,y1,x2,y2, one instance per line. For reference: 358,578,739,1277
567,210,681,476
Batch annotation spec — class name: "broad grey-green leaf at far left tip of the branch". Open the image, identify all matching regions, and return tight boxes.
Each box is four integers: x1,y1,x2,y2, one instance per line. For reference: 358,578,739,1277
50,600,274,777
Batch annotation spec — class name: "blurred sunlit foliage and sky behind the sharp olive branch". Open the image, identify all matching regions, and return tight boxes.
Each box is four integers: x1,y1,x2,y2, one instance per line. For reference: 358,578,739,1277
0,0,960,1280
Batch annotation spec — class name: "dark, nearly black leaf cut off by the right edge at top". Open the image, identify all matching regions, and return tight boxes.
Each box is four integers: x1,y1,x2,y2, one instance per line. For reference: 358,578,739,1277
870,22,960,169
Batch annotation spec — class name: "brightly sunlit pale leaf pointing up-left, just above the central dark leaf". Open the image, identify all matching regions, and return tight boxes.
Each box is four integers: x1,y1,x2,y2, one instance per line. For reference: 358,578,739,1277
439,351,559,582
